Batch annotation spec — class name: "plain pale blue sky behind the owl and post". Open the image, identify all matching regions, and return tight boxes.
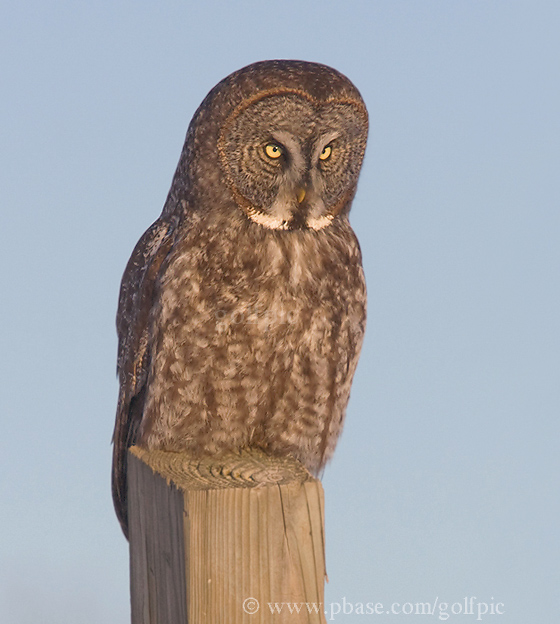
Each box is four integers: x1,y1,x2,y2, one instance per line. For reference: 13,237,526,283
0,0,560,624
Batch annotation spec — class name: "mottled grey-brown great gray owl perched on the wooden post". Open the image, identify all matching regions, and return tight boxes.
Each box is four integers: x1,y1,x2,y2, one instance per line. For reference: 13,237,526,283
113,61,368,535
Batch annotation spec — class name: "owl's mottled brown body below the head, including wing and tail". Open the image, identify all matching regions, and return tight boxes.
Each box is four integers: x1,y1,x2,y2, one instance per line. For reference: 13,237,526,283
113,212,366,532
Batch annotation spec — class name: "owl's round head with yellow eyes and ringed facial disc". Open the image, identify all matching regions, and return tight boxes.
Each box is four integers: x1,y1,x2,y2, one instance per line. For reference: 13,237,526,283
167,61,368,230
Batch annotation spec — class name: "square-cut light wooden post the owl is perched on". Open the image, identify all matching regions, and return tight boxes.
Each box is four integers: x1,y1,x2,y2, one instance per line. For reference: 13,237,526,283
128,447,326,624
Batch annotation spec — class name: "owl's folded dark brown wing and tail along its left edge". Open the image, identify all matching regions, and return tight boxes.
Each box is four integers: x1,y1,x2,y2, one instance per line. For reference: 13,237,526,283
112,217,176,537
